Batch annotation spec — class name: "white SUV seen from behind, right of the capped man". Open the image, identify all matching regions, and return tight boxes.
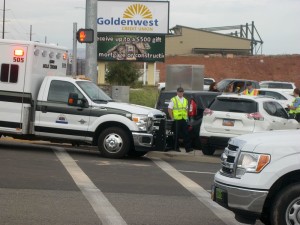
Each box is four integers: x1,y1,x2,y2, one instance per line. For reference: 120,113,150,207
199,94,300,155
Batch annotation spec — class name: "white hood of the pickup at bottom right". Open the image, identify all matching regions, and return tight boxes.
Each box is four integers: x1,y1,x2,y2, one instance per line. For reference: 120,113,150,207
230,130,300,152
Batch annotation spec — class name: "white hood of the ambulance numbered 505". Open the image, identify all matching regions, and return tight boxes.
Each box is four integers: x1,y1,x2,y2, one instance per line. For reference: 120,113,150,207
97,102,165,115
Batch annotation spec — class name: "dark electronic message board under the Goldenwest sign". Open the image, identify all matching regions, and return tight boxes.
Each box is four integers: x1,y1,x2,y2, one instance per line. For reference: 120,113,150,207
97,32,165,62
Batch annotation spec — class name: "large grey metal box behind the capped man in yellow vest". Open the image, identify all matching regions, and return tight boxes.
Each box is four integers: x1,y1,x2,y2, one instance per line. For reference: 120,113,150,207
165,64,204,91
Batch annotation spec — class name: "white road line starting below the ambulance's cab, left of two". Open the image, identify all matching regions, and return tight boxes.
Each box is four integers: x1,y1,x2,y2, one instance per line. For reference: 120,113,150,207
52,147,127,225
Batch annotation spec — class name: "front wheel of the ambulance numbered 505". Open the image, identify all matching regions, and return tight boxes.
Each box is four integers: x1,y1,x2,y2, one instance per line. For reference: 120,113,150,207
98,127,130,159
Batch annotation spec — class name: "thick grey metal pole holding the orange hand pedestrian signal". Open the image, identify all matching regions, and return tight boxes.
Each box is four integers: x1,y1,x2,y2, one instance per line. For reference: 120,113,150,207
85,0,98,84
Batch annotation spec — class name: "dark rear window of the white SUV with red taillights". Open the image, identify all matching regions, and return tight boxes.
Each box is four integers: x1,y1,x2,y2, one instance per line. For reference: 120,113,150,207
210,98,257,113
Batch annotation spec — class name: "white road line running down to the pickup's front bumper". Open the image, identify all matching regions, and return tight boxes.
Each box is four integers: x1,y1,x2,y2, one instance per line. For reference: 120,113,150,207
151,158,247,225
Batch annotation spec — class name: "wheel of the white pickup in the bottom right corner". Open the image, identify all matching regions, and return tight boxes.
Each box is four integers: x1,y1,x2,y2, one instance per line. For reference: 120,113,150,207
270,183,300,225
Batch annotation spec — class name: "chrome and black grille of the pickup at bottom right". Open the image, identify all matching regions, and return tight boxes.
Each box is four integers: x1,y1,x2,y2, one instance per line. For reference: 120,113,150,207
220,144,239,177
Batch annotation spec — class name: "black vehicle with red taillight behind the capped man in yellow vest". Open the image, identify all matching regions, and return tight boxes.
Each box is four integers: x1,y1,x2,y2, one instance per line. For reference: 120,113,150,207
155,90,221,149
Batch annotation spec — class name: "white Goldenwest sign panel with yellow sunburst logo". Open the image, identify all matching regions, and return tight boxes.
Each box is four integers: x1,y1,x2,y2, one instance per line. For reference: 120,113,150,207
97,1,169,34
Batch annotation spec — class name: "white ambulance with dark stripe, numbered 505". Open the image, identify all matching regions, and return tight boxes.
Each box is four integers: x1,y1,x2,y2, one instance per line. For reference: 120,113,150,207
0,40,166,158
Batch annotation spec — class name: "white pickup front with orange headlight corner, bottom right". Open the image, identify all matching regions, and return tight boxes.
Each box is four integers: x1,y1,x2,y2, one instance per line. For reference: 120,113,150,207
212,130,300,225
